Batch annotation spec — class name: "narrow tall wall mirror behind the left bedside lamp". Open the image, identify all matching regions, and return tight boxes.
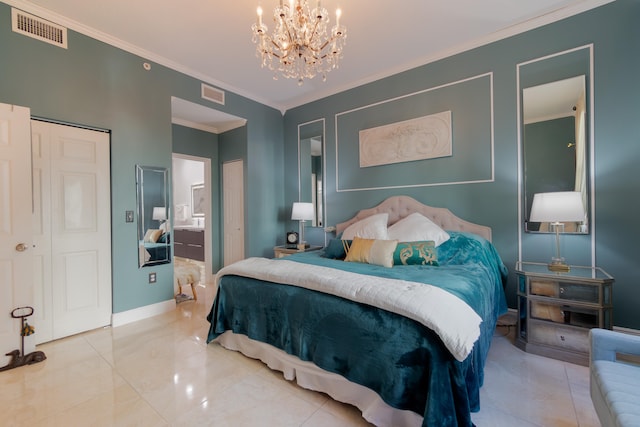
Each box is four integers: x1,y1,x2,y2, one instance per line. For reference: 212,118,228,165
298,119,325,228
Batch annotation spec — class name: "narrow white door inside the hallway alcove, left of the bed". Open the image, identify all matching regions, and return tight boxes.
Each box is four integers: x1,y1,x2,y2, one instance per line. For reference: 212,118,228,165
222,160,244,265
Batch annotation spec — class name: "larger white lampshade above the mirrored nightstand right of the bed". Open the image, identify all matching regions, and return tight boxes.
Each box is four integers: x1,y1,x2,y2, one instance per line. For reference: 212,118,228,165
529,191,585,222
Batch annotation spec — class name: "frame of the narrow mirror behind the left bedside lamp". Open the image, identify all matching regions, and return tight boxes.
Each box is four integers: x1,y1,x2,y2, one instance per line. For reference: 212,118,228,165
298,117,327,228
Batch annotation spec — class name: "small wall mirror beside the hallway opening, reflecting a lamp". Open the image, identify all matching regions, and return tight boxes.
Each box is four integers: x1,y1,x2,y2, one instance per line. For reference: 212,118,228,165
136,165,171,267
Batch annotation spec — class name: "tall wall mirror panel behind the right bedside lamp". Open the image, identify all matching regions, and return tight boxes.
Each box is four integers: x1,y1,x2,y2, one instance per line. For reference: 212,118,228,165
518,46,593,234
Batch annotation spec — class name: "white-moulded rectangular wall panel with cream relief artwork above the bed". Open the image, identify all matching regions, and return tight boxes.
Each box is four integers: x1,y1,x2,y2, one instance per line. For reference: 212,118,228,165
335,72,495,192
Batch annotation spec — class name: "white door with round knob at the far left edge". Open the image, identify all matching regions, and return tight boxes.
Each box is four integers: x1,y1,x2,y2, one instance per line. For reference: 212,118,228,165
0,104,35,366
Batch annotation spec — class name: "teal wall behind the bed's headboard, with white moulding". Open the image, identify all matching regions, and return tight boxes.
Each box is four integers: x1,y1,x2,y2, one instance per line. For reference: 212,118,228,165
284,0,640,328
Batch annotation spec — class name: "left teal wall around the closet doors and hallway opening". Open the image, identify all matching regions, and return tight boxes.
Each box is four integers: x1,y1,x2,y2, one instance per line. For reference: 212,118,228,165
0,3,284,313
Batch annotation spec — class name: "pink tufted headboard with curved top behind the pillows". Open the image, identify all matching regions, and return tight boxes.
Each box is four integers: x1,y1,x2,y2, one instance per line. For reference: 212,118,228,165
336,196,491,241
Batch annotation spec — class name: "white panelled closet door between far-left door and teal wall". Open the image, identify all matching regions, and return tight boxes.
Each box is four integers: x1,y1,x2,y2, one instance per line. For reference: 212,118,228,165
31,121,112,342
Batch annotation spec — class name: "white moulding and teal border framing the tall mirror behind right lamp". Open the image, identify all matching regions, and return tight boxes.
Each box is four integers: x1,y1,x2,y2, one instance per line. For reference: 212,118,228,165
516,45,595,234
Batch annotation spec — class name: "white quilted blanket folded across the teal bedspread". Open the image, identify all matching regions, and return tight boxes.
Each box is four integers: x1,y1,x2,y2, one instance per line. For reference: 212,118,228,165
216,258,482,361
